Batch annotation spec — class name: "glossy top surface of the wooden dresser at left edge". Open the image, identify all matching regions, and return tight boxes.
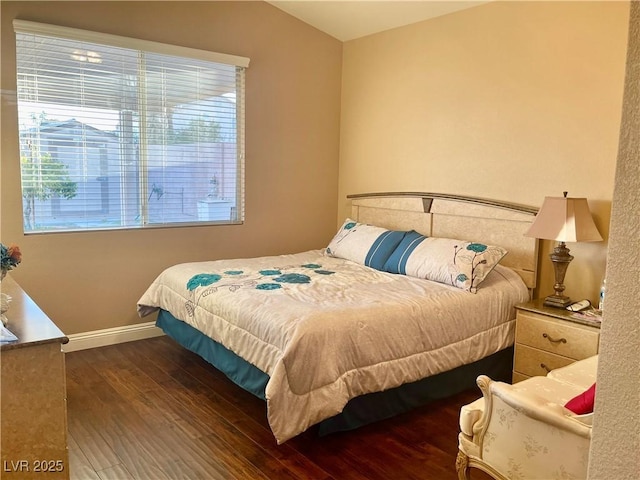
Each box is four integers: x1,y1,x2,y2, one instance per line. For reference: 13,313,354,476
0,275,69,350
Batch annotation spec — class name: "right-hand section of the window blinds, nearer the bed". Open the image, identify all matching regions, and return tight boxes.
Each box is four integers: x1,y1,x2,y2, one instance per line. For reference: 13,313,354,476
141,54,239,223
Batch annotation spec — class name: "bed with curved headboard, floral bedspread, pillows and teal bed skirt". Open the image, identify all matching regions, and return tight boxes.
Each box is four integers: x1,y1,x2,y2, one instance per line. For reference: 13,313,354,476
138,192,538,443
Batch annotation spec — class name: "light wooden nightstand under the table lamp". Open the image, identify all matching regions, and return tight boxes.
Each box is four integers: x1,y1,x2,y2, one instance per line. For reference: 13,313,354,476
513,299,600,383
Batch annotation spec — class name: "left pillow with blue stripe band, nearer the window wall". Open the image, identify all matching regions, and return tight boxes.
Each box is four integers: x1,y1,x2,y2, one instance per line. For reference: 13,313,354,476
326,218,406,270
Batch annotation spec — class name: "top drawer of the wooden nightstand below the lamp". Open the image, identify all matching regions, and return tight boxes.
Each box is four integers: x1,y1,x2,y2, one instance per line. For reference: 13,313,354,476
516,311,600,360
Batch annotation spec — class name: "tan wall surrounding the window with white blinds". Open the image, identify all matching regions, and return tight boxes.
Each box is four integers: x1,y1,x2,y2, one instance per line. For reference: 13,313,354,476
0,1,342,334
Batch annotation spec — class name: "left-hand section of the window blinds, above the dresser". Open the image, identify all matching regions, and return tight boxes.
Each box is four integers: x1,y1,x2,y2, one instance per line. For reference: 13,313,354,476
16,33,137,231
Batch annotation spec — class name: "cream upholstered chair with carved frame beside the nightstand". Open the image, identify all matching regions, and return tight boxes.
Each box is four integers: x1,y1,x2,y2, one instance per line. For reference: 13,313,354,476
456,356,597,480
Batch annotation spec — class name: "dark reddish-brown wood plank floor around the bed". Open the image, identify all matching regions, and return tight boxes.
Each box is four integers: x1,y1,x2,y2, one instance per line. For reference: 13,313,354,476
66,337,486,480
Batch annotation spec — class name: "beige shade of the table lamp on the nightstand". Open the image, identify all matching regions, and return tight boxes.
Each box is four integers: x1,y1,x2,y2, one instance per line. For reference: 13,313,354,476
525,193,602,242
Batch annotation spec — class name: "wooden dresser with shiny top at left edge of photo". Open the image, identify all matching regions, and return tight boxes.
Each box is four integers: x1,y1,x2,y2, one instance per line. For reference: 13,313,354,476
0,276,69,480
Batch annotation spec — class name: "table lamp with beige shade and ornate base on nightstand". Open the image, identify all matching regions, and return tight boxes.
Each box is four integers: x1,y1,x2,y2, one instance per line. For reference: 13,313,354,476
525,192,602,308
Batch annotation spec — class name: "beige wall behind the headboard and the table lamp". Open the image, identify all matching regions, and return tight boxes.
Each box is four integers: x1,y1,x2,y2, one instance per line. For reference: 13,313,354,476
338,2,629,302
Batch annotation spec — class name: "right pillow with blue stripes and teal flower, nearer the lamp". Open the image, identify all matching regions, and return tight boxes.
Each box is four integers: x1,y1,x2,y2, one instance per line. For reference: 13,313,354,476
383,231,507,293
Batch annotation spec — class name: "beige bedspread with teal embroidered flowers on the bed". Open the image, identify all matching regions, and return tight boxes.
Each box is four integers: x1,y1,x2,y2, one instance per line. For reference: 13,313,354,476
138,250,528,443
